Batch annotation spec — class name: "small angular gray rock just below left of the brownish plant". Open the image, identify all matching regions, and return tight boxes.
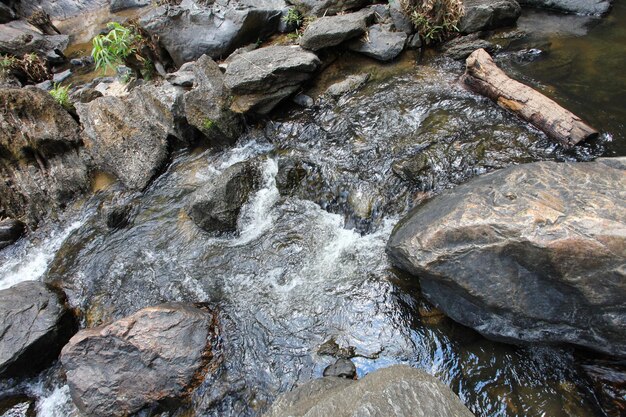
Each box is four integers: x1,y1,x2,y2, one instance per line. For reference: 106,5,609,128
348,24,407,61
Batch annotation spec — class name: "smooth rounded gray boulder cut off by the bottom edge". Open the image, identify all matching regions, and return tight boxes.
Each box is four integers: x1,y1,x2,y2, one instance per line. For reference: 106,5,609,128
264,365,473,417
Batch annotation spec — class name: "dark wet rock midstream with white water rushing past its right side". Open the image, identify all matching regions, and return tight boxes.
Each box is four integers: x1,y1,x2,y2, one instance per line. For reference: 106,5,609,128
188,161,261,234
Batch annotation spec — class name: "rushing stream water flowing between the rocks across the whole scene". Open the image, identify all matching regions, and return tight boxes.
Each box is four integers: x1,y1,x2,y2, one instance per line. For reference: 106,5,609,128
0,1,626,417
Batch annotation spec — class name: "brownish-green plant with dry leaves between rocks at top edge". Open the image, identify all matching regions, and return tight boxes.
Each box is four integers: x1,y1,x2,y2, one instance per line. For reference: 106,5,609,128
400,0,464,44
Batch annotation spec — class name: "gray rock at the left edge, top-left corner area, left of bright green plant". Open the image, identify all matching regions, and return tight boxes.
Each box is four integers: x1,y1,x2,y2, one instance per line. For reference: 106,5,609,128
0,20,69,63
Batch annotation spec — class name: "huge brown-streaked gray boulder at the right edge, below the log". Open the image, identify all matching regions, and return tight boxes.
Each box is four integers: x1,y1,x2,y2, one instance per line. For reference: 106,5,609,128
387,158,626,356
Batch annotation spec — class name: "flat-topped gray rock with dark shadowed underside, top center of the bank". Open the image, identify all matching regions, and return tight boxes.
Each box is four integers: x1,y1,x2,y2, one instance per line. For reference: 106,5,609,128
300,11,374,51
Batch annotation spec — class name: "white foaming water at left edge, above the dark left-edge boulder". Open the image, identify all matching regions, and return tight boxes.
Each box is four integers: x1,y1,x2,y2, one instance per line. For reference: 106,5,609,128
0,221,84,290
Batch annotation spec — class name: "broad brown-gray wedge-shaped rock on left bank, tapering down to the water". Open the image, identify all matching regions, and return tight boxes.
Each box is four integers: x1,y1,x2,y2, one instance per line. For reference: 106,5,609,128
76,83,184,190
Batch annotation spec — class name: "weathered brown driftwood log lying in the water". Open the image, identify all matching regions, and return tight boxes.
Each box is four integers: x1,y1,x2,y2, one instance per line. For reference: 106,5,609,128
461,49,598,146
